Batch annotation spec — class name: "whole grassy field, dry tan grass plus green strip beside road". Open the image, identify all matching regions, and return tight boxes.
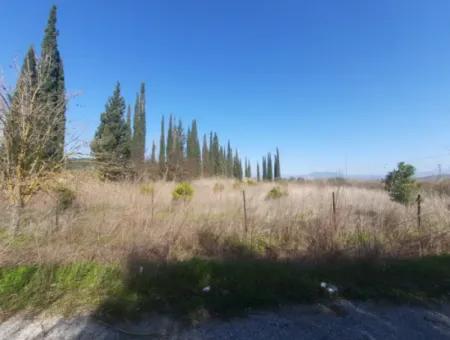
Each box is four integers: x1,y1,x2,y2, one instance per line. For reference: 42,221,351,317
0,171,450,319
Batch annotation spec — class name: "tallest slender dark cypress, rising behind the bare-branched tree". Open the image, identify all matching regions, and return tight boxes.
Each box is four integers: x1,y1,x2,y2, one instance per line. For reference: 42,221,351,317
39,6,66,160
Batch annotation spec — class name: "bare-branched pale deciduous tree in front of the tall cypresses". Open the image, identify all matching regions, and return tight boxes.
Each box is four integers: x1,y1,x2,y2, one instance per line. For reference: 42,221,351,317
0,49,66,232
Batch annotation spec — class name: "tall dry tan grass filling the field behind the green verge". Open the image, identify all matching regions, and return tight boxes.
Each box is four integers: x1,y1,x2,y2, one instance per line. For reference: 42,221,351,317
0,172,450,265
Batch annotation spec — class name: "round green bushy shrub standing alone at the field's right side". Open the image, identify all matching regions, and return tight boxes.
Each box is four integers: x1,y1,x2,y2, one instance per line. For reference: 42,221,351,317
384,162,419,205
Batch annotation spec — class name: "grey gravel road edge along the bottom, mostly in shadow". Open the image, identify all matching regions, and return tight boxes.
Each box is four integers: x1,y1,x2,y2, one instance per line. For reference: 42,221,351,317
0,300,450,340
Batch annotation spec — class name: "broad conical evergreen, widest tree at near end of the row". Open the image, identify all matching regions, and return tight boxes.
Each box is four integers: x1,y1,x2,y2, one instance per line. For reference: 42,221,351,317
91,83,130,180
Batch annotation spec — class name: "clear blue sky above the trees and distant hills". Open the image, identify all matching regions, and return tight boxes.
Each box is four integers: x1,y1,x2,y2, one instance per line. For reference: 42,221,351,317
0,0,450,175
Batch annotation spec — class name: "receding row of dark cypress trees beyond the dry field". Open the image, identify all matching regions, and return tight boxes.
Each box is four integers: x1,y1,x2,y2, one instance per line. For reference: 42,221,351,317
91,83,281,180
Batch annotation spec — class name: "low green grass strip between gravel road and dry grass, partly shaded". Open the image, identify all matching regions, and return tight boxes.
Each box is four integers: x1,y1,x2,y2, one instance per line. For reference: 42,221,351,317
0,255,450,318
